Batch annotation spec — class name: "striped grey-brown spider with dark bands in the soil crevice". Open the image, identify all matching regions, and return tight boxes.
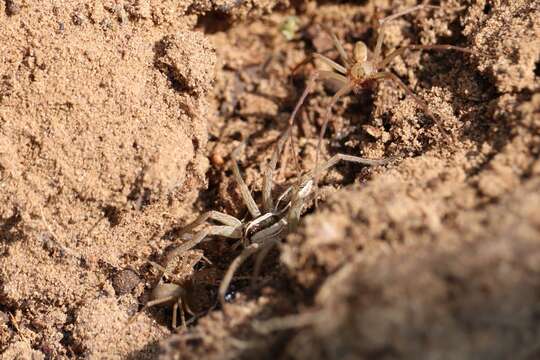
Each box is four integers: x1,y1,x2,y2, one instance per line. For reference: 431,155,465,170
162,128,392,305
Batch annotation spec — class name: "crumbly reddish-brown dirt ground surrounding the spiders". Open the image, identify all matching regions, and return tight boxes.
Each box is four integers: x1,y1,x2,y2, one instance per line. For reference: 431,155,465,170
0,0,540,359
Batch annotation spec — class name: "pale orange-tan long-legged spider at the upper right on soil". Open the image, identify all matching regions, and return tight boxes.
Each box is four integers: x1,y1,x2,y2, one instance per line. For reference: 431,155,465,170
289,5,475,191
